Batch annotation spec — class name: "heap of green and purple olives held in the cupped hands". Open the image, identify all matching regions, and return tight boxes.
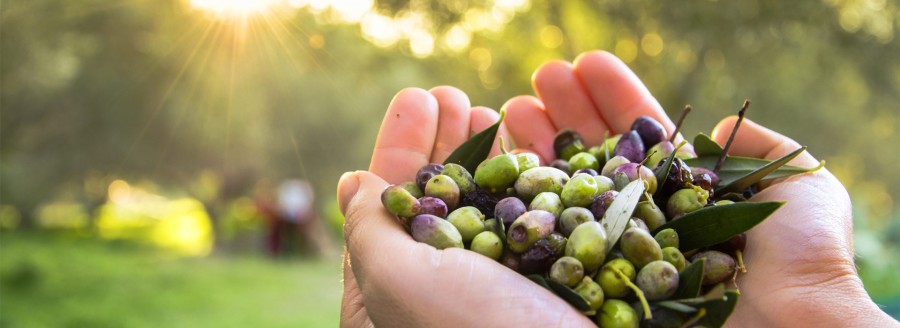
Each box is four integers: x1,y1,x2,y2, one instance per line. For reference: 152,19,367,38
381,116,753,327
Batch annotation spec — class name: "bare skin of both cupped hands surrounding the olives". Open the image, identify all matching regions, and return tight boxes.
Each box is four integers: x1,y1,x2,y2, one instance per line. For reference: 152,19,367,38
338,51,898,327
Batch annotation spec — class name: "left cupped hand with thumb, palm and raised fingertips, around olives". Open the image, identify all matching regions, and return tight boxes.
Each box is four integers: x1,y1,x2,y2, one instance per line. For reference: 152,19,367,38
338,87,593,327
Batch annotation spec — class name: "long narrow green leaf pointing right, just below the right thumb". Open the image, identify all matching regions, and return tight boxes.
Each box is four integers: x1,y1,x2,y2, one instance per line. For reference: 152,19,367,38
684,150,825,194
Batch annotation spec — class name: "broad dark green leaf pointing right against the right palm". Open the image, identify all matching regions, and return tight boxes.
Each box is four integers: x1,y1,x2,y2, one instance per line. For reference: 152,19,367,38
653,202,784,251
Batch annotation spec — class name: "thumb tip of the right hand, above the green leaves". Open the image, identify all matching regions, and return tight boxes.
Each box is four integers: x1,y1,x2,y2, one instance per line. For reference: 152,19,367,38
712,116,819,167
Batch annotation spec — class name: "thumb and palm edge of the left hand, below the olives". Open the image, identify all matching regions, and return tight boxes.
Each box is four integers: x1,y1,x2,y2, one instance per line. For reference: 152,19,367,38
338,172,590,327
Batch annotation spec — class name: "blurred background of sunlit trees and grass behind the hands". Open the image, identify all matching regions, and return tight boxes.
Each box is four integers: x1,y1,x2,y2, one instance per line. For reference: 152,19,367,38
0,0,900,327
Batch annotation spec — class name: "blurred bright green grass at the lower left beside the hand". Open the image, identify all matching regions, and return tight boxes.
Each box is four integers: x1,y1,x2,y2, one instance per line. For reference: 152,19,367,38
0,233,341,327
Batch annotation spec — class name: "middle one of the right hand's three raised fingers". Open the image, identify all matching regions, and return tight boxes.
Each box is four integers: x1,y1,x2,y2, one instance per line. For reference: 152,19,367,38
532,61,608,146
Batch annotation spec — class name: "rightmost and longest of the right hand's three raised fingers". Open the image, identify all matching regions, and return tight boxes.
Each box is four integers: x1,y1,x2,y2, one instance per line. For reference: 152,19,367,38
574,51,675,135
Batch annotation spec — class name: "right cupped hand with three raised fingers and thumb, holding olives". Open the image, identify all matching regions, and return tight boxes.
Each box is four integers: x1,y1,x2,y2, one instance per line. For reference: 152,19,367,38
505,52,897,327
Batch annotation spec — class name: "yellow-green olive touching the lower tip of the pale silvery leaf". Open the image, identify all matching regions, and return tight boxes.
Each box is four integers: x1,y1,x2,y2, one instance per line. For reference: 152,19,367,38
566,221,607,272
